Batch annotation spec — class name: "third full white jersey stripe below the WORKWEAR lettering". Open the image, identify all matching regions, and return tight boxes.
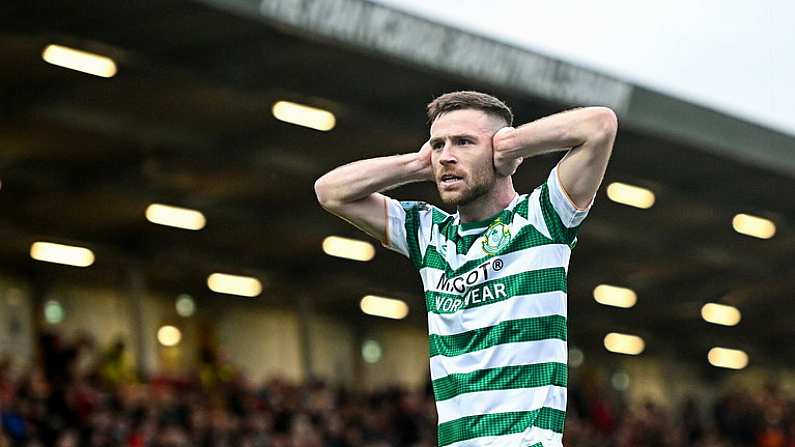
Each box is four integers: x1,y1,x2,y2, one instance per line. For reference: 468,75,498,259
436,385,566,424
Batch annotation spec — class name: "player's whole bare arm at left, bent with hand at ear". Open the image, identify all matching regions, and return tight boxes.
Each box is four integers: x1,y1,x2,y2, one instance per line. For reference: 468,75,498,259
315,143,433,243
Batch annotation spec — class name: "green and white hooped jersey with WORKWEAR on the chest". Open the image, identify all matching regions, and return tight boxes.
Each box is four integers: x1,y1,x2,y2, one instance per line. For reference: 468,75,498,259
385,168,590,447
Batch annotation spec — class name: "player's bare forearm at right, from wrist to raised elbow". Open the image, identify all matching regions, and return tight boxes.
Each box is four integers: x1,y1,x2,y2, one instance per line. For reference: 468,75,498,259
494,107,616,159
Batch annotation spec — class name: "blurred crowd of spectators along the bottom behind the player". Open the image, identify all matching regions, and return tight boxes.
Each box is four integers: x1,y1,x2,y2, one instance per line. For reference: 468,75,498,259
0,335,795,447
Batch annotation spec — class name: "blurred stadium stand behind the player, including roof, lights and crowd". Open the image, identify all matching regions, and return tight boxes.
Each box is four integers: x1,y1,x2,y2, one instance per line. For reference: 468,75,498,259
0,0,795,447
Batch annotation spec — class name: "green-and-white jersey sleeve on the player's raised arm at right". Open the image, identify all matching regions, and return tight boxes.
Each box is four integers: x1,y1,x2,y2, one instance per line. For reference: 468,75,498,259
538,166,595,248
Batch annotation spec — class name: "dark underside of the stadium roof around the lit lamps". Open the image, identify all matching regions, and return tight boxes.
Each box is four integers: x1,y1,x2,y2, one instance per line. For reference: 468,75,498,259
0,0,795,365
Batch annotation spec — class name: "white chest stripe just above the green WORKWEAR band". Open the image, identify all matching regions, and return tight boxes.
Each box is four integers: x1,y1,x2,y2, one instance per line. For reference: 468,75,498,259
420,244,571,293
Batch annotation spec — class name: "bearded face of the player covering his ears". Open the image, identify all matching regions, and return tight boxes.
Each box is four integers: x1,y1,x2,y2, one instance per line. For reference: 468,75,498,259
430,109,502,206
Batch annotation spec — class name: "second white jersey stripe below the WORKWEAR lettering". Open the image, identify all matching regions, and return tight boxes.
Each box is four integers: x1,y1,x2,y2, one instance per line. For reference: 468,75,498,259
430,338,569,380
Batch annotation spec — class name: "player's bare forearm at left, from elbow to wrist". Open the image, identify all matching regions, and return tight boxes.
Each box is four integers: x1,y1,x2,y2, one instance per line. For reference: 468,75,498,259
315,153,431,209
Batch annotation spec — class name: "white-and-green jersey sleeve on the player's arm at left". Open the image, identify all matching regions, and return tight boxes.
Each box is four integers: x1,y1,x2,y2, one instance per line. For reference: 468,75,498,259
382,198,431,269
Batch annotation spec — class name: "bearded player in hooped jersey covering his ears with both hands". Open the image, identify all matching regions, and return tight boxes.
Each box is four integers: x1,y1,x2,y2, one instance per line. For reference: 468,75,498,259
315,91,617,447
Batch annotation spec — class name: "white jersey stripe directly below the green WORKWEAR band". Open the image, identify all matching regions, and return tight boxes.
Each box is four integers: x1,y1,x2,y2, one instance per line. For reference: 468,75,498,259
428,291,567,335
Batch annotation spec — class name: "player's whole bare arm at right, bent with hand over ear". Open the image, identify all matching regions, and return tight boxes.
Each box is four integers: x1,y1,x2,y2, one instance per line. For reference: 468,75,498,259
493,107,618,209
